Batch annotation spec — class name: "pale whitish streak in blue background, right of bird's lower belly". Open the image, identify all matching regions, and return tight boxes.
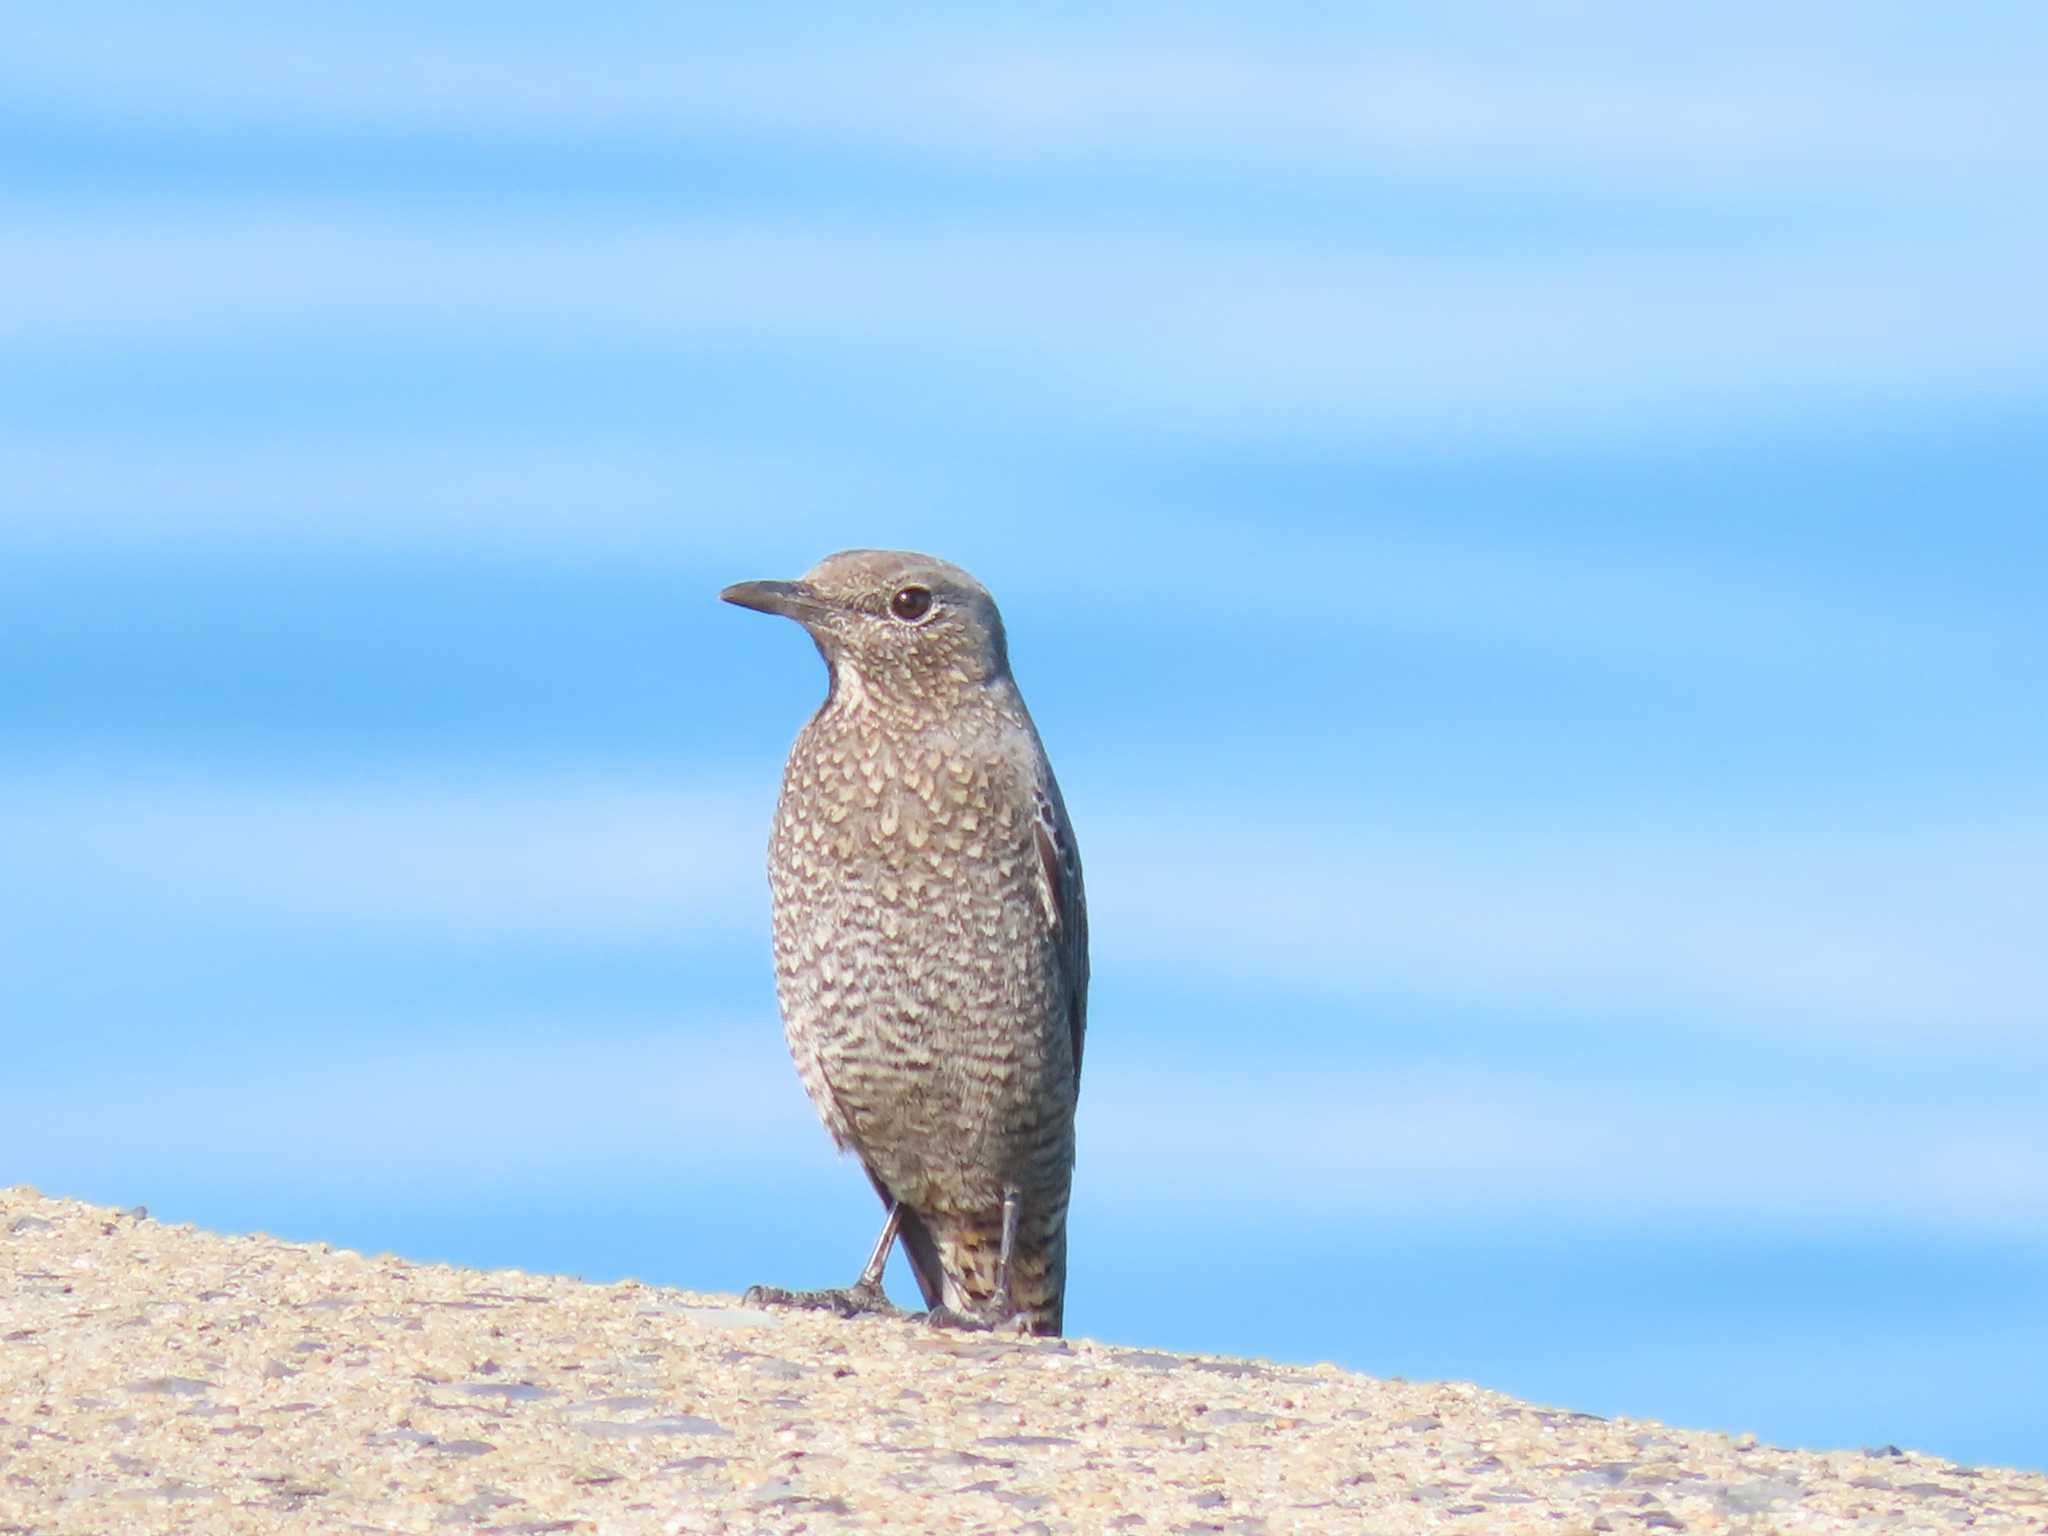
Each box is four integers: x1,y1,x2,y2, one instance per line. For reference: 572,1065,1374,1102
1081,1056,2048,1235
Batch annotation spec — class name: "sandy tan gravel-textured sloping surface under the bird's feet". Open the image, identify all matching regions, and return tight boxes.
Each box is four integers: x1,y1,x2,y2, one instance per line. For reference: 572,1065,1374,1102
0,1190,2048,1536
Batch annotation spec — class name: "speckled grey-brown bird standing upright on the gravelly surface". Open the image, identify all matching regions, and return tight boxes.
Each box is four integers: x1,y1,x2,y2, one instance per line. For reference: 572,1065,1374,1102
719,549,1087,1335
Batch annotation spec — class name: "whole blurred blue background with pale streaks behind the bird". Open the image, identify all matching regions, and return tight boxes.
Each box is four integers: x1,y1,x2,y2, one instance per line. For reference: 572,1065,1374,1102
0,0,2048,1466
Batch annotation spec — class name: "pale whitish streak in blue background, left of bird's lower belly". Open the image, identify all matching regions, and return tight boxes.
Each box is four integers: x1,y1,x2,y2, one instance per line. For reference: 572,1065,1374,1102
0,1028,829,1196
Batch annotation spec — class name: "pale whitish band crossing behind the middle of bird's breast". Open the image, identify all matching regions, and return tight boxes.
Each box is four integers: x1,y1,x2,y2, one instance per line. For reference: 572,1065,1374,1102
0,774,2048,1053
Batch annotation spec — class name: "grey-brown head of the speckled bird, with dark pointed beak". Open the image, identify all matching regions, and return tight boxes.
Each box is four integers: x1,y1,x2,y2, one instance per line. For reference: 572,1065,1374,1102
719,549,1010,702
